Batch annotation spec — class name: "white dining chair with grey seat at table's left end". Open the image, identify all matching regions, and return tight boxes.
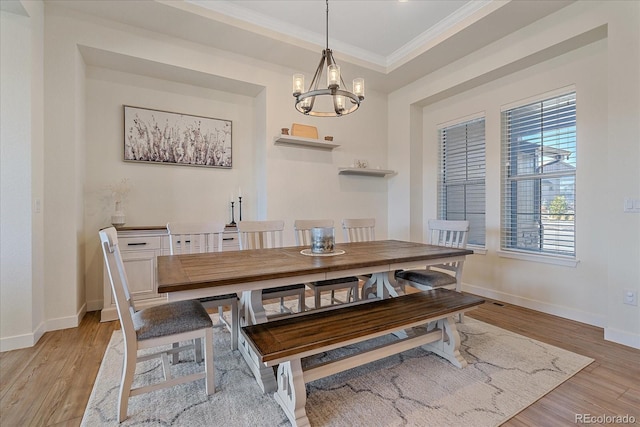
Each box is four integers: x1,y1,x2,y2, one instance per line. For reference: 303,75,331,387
99,227,215,422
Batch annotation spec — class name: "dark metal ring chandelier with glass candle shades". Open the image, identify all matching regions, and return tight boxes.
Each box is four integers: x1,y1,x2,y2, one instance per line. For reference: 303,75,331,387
293,0,364,117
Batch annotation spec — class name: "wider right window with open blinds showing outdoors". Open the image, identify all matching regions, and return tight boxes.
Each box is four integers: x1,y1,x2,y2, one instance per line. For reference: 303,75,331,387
501,92,576,257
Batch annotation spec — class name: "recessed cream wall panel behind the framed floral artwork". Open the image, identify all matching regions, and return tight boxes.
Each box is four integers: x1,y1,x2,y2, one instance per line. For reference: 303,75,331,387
83,70,255,310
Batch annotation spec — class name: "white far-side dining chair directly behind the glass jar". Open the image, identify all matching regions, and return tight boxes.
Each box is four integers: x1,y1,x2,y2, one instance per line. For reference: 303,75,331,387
293,219,360,308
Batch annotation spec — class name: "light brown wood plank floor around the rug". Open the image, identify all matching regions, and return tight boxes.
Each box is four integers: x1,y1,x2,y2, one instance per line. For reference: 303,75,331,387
0,301,640,426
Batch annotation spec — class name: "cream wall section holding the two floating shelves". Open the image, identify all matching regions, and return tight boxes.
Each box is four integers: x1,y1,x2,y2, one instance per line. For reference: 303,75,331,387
265,79,393,245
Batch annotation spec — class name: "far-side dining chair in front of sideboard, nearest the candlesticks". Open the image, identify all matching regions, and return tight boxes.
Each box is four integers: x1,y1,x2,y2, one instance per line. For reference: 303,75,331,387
167,222,239,350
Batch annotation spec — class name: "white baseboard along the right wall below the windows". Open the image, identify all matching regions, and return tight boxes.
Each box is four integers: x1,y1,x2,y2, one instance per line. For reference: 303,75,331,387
462,283,606,328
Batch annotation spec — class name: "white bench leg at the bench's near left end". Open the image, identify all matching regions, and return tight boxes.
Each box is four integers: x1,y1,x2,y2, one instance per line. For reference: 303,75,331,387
273,359,310,427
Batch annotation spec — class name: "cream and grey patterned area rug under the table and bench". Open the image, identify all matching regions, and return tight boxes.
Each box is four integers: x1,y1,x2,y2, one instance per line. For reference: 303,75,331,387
82,306,593,427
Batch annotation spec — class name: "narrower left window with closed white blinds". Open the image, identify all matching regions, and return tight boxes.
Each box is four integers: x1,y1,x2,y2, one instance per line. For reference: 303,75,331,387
438,118,485,246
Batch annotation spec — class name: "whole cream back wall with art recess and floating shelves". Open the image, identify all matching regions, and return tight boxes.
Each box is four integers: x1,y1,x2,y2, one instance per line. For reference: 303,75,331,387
38,4,387,328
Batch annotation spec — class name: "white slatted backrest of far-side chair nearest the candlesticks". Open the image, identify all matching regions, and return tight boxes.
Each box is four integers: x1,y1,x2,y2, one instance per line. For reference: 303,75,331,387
167,222,225,255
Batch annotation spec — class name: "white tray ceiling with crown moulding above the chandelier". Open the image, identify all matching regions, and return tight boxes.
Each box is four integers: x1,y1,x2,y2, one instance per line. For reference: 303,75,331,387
45,0,575,93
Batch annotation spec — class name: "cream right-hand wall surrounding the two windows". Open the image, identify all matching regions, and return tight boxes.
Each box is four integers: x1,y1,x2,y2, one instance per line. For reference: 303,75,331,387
389,2,640,347
